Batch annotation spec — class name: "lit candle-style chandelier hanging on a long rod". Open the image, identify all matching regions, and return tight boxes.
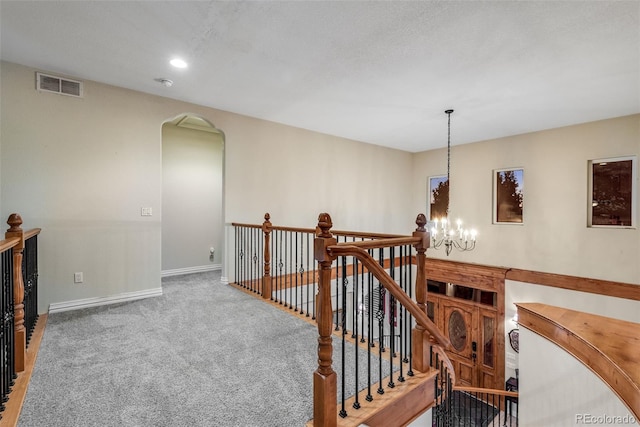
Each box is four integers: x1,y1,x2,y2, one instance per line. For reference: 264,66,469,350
431,110,476,256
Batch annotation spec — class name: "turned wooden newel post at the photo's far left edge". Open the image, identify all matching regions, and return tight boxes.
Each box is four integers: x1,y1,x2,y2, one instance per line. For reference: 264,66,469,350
5,213,27,372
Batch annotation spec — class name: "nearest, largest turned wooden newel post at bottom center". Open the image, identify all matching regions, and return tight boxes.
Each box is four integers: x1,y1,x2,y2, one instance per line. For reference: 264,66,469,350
313,213,338,427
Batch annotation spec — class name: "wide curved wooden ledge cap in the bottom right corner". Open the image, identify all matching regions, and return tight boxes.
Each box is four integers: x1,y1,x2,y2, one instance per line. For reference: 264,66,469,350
516,303,640,419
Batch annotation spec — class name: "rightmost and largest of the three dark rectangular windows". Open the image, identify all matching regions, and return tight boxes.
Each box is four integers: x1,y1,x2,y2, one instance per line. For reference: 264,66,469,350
587,156,637,228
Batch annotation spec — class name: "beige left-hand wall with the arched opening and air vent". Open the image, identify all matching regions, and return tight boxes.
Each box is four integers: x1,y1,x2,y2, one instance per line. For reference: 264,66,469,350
0,62,415,311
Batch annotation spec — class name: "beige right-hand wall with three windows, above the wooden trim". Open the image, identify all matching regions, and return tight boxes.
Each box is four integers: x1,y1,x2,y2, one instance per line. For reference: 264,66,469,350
413,115,640,284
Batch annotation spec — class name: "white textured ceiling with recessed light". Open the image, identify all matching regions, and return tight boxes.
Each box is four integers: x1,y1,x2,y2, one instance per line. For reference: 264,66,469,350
0,0,640,152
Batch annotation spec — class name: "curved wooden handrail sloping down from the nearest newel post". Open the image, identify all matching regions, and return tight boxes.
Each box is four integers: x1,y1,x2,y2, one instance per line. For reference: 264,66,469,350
327,242,451,349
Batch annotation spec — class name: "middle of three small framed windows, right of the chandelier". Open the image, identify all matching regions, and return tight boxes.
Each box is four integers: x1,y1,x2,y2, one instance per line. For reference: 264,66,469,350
493,168,524,224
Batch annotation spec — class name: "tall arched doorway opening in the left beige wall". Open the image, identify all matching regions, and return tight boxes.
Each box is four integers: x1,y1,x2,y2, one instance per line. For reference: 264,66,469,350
161,113,224,276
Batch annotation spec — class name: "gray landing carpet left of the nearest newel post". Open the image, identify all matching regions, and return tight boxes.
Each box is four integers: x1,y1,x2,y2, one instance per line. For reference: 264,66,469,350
18,272,318,427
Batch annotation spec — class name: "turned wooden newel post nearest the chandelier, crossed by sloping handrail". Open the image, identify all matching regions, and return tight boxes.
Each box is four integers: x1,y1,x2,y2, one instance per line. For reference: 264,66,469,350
412,214,431,372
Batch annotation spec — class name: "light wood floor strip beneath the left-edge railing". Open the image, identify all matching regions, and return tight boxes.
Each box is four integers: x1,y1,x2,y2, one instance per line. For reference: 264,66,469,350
0,314,47,427
